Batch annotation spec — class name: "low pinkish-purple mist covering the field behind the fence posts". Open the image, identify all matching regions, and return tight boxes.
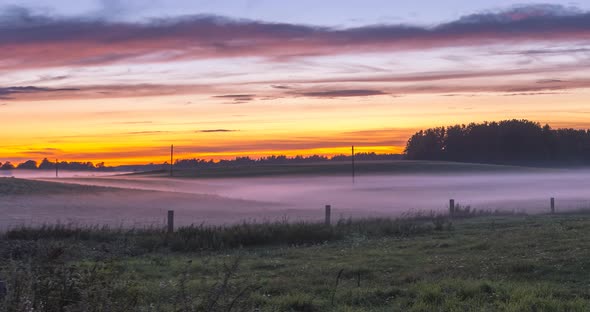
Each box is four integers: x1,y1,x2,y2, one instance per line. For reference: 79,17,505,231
0,166,590,227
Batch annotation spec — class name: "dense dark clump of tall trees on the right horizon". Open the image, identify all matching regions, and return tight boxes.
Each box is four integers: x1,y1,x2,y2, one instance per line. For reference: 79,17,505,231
405,119,590,164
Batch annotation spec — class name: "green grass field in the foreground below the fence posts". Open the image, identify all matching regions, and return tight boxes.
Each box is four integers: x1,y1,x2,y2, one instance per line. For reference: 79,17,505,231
0,213,590,311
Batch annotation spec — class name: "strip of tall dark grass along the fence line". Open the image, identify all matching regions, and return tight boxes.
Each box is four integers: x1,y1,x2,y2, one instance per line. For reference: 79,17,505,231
0,205,517,252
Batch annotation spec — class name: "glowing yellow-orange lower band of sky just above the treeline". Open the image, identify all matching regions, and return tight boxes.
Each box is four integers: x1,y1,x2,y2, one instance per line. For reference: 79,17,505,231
0,89,590,165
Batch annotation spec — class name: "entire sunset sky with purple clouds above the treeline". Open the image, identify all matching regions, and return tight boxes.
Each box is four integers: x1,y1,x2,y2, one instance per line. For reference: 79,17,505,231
0,0,590,165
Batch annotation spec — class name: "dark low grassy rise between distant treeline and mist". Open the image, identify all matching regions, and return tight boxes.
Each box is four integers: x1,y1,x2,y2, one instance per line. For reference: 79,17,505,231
140,160,537,178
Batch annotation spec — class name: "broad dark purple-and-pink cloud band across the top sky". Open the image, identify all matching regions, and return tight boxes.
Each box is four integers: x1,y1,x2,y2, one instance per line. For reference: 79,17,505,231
0,5,590,69
